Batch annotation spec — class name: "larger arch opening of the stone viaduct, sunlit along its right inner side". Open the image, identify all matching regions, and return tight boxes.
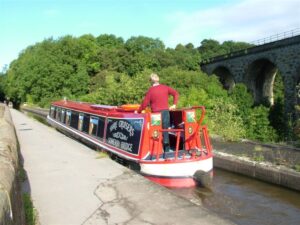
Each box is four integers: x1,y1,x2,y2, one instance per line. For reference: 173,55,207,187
246,58,278,106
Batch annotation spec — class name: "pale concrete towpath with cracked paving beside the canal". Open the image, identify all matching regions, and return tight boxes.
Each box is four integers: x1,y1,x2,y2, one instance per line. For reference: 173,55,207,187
11,109,231,225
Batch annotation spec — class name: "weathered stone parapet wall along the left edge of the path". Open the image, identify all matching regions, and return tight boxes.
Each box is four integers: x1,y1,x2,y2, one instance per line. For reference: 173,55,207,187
0,103,25,225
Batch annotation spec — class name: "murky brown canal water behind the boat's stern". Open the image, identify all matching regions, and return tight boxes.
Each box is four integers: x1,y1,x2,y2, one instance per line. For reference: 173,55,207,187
172,169,300,225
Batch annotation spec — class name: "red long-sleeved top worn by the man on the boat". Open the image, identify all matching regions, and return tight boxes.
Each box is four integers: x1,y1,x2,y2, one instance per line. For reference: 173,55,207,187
138,84,179,112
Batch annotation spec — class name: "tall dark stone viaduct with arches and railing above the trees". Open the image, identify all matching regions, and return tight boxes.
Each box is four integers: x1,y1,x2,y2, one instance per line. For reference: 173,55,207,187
200,35,300,115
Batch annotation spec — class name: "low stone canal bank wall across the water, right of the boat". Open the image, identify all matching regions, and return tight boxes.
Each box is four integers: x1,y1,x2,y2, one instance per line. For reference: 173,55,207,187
212,139,300,191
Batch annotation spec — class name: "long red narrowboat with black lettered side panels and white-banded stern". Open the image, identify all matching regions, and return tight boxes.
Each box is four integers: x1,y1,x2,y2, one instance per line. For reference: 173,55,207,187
47,100,213,188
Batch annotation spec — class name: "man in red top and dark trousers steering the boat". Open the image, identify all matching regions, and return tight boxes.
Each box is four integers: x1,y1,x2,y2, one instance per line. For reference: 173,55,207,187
138,73,179,152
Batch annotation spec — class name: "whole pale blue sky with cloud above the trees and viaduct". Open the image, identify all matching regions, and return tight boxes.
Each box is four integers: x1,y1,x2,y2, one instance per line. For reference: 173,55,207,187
0,0,300,71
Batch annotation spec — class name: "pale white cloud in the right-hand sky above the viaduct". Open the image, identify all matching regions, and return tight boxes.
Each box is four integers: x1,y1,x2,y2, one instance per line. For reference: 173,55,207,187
165,0,300,47
